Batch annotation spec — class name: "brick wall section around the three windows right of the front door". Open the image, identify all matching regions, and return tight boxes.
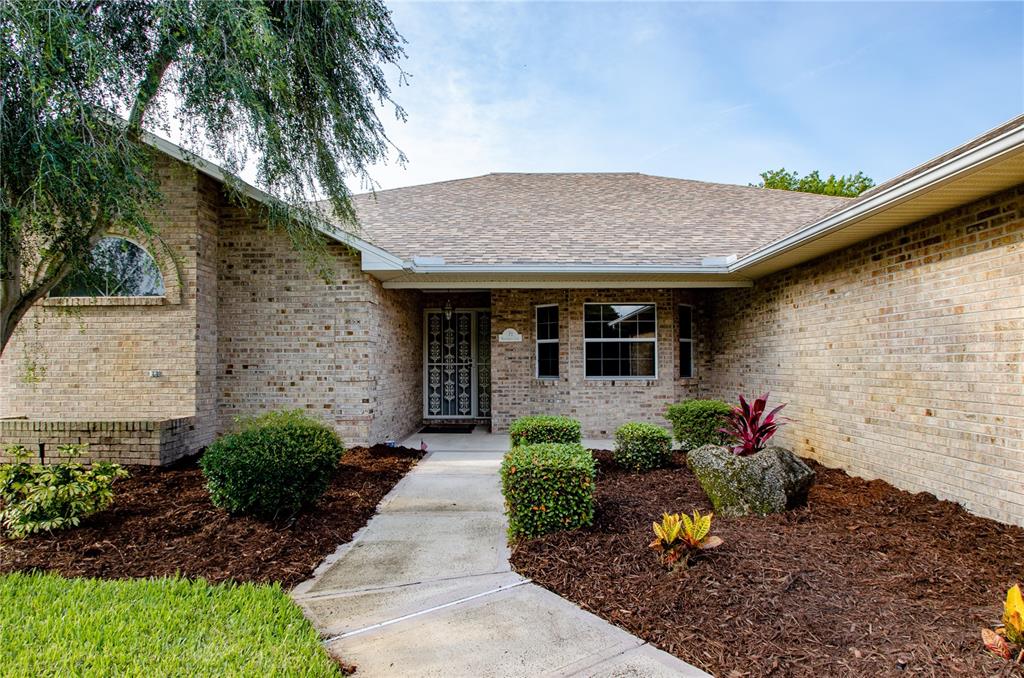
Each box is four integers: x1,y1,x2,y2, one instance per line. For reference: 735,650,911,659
490,290,708,437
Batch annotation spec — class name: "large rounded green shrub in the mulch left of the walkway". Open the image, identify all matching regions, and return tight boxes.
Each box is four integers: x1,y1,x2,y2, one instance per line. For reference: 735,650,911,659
200,410,345,520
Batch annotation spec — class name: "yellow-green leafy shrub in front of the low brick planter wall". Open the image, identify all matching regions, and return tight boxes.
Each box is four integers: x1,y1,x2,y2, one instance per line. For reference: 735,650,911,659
0,444,128,539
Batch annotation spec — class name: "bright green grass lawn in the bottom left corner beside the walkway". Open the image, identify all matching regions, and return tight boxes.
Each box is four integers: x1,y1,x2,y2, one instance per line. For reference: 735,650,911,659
0,575,342,678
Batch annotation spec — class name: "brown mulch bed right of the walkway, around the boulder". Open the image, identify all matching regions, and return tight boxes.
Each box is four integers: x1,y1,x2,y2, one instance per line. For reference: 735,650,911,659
512,452,1024,678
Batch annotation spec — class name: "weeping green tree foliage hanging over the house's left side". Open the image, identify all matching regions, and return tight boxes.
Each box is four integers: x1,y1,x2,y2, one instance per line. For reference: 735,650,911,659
0,0,404,353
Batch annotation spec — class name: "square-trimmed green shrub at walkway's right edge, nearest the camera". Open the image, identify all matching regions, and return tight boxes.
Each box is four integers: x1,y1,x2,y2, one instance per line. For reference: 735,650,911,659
501,442,595,539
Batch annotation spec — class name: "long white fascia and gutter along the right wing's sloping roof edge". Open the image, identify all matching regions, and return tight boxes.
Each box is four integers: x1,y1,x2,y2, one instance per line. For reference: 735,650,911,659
728,122,1024,272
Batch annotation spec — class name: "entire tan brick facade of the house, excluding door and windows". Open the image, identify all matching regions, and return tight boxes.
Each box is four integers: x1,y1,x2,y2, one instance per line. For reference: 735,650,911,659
0,148,1024,524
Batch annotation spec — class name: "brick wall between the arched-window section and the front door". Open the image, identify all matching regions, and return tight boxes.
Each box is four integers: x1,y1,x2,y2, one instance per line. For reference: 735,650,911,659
217,206,422,444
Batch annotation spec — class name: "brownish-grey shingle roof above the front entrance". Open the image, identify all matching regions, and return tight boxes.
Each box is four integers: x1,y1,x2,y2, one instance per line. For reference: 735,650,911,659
335,173,849,266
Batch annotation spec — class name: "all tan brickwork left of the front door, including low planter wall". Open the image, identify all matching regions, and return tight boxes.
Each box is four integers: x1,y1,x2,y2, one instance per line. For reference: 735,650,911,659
0,152,422,464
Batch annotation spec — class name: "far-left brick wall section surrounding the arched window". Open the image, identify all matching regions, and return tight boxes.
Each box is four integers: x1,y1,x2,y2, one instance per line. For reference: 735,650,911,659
0,156,200,456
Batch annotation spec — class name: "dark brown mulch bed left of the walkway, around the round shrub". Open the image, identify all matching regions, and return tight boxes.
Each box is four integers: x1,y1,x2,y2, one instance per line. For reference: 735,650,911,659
0,446,422,588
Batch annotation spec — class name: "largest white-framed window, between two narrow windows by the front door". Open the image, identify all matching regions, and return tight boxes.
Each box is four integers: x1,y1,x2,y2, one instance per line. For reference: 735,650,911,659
583,304,657,379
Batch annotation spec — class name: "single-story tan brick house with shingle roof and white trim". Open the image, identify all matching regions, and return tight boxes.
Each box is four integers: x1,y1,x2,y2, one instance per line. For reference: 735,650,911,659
0,116,1024,524
